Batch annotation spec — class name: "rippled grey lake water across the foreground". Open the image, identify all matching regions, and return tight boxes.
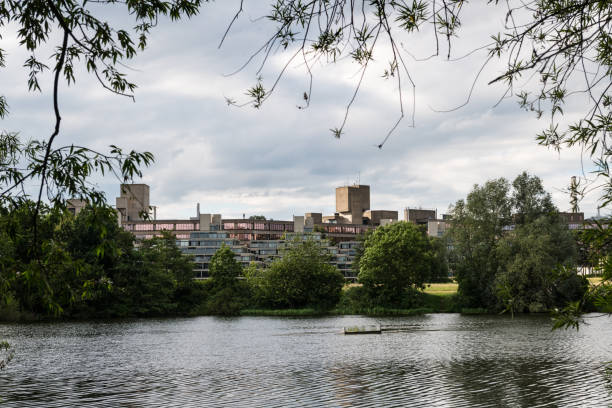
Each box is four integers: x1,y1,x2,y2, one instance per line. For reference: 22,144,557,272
0,314,612,407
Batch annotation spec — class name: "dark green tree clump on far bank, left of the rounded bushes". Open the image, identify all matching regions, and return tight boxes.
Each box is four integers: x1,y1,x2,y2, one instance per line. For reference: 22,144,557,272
0,203,198,318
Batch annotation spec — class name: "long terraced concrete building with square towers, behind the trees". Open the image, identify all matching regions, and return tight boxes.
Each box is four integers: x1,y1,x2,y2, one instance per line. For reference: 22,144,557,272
113,184,412,281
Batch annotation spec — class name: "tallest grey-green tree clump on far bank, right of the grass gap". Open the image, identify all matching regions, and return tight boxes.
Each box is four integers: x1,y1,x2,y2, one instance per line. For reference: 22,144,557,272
450,172,588,313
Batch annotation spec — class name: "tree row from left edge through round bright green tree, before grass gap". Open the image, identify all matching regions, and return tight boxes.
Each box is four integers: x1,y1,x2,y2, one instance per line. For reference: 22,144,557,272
0,204,447,319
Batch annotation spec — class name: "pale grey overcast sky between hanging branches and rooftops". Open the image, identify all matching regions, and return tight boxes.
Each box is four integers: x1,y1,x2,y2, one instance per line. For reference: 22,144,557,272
0,1,597,219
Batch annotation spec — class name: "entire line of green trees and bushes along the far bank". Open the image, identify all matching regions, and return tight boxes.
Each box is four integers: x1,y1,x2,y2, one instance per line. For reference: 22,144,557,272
0,173,612,318
